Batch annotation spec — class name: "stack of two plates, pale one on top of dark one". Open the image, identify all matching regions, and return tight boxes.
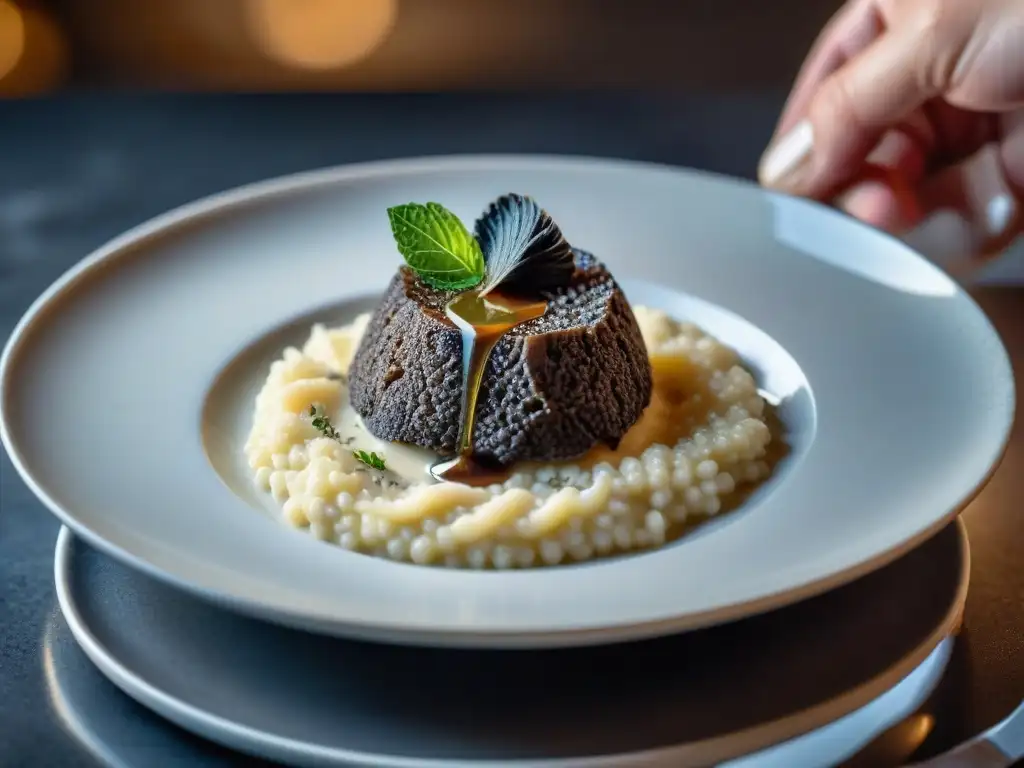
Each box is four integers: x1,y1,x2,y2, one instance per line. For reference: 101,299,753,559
0,158,1014,768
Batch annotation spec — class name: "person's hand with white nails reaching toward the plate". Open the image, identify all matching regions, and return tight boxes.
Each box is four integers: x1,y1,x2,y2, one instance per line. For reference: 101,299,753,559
759,0,1024,255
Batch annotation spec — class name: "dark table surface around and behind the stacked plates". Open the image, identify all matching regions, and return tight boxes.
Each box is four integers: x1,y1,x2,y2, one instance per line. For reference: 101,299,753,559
0,92,1024,768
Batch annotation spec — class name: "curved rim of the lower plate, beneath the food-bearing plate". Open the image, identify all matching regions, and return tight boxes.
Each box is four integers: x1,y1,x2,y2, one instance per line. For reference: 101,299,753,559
53,516,971,768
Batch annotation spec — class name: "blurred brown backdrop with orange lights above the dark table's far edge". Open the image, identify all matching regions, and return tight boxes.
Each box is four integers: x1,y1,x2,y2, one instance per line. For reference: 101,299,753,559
0,0,841,95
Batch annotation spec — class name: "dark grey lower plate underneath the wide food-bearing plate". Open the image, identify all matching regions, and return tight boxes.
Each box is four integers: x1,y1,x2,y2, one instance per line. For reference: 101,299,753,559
54,523,970,768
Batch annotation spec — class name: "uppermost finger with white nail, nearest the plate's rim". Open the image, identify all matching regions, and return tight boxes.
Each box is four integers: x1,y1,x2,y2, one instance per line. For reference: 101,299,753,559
759,9,972,200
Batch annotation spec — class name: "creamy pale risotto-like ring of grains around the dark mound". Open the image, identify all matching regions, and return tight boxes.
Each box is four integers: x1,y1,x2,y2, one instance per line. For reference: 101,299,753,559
245,307,771,568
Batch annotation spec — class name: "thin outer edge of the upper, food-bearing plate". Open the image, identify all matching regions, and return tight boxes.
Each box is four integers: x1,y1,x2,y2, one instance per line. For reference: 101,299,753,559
0,154,1016,648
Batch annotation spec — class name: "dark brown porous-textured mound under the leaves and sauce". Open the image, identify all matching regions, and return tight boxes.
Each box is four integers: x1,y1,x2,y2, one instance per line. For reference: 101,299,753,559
349,251,651,466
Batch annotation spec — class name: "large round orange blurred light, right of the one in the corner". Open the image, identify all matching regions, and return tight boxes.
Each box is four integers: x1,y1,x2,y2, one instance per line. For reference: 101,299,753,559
245,0,397,70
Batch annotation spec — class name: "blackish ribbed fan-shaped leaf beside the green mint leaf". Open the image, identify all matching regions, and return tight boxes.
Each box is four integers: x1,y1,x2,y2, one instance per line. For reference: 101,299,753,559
475,195,575,296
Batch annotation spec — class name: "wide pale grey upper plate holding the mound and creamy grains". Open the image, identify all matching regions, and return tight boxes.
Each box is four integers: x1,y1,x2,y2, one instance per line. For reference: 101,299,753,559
0,158,1014,646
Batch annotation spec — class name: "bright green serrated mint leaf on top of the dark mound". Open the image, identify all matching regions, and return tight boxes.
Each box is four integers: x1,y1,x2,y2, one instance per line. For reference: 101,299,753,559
387,203,483,291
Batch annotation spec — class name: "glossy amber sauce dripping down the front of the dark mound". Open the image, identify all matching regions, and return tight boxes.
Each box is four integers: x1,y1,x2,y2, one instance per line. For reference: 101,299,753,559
430,291,548,485
